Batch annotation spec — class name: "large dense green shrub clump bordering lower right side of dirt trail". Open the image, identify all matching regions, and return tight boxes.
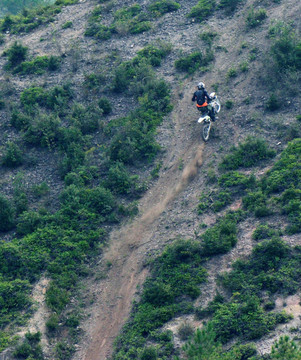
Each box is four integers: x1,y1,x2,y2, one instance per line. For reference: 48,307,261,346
114,240,206,359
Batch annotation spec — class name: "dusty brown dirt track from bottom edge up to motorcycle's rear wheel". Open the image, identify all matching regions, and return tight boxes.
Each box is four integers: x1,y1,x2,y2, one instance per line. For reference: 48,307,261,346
80,146,203,360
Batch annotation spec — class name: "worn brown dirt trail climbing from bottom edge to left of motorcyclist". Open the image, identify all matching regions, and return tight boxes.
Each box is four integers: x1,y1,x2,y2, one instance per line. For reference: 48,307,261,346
74,83,204,360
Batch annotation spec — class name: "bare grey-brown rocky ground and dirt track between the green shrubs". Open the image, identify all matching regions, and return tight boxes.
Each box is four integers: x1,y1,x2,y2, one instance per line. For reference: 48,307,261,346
0,0,301,360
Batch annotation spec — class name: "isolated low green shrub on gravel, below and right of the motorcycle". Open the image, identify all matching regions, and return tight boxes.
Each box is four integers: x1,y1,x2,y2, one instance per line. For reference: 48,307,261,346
220,137,276,170
